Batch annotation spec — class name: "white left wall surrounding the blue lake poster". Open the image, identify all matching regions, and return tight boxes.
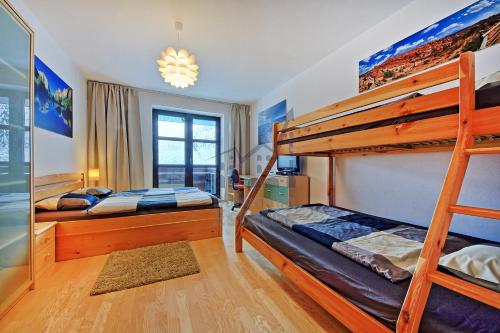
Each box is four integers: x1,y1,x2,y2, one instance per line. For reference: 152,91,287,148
10,0,87,176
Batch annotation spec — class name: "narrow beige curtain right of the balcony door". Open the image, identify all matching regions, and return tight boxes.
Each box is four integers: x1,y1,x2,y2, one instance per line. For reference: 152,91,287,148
228,104,250,175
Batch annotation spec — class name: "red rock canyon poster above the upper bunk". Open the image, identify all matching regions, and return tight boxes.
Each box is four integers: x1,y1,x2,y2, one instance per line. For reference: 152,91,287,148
359,0,500,92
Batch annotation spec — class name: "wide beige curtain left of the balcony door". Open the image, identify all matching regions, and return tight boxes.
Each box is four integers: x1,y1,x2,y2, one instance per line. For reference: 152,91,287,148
87,81,144,191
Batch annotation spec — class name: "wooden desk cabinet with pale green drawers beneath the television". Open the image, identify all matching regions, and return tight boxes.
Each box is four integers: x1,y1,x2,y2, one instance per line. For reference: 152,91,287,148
262,176,309,209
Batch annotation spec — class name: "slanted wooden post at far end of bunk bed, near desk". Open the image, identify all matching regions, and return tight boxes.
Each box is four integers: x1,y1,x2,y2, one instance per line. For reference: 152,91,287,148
234,123,278,252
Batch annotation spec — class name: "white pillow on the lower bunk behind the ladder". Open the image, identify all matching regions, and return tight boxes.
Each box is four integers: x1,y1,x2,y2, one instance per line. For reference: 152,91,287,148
439,244,500,291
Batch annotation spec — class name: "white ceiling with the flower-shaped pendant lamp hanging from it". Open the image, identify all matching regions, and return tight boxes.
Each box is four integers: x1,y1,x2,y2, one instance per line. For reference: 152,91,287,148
25,0,410,103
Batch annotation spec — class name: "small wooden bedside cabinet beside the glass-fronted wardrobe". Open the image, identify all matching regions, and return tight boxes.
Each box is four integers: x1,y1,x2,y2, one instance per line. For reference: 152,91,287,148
35,222,57,279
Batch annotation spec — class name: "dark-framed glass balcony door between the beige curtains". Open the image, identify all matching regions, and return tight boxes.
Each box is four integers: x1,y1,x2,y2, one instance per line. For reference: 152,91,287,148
153,110,220,196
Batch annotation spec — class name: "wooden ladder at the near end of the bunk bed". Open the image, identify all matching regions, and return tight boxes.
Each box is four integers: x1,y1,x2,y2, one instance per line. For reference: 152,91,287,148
397,52,500,332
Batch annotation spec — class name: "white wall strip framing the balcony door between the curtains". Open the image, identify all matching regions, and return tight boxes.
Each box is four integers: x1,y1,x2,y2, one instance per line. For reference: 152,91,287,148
139,91,231,187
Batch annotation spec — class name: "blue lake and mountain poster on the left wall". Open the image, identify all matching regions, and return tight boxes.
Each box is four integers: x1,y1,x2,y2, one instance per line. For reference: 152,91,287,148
35,56,73,138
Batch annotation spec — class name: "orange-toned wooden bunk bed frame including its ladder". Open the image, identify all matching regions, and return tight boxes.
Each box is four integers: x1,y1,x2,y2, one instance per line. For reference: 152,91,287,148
235,52,500,332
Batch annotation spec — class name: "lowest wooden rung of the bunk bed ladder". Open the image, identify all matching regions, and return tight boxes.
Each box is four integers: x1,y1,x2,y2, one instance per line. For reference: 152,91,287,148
427,271,500,309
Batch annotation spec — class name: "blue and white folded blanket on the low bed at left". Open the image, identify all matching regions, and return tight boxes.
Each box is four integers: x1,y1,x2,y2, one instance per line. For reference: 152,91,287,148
88,187,213,215
